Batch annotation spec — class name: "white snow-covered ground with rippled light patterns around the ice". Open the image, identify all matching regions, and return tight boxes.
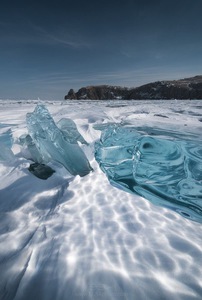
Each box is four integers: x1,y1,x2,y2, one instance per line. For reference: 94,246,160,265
0,100,202,300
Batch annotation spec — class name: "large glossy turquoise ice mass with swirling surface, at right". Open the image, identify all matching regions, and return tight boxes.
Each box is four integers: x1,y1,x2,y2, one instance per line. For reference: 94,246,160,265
95,124,202,222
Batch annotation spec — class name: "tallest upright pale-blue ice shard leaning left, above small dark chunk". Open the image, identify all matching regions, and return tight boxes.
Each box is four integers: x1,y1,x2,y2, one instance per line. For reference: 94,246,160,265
27,105,92,176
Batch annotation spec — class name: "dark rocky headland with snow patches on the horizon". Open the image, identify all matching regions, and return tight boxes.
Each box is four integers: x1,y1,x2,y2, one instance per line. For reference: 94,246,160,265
65,75,202,100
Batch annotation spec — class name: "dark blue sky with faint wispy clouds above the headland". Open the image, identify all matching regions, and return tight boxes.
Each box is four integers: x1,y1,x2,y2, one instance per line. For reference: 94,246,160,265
0,0,202,99
